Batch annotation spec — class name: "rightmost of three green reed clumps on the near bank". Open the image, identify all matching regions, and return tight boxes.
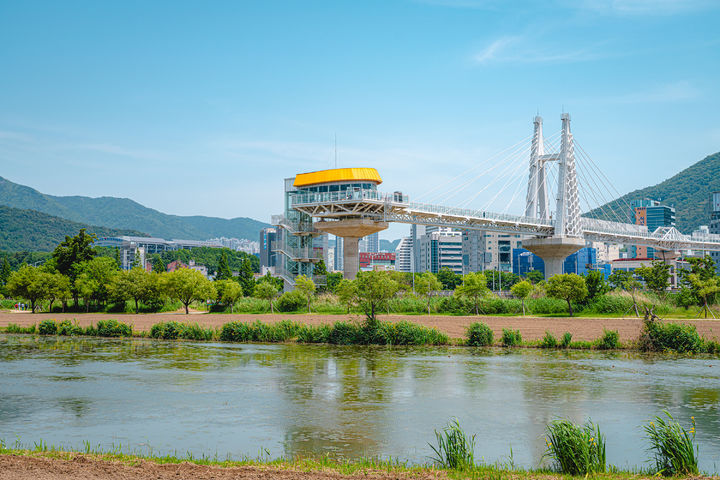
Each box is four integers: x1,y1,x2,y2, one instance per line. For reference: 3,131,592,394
645,410,698,477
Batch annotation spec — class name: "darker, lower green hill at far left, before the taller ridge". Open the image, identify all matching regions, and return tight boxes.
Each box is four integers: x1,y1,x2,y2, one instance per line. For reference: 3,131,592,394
0,205,145,252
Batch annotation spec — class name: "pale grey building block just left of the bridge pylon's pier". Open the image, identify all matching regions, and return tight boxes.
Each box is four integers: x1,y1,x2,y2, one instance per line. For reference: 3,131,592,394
462,230,522,273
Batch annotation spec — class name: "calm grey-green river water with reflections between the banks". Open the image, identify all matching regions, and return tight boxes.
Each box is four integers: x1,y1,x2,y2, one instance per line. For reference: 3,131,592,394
0,335,720,472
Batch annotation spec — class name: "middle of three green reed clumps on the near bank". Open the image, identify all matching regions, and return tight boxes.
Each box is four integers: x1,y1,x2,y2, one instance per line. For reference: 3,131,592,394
545,420,605,475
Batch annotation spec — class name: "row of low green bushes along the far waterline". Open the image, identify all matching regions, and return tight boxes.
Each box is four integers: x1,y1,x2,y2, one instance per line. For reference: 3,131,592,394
4,318,720,355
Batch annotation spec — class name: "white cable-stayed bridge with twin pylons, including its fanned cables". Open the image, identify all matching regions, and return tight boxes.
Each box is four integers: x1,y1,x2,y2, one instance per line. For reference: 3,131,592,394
290,114,720,277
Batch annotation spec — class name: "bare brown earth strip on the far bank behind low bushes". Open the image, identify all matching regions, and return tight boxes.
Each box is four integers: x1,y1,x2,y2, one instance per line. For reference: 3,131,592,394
0,310,720,341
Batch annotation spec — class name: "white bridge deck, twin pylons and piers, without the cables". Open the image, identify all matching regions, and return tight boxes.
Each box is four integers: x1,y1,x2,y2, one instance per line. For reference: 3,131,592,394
290,114,720,277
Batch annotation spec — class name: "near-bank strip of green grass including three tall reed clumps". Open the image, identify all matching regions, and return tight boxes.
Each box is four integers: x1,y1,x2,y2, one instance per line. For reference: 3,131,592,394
0,411,700,479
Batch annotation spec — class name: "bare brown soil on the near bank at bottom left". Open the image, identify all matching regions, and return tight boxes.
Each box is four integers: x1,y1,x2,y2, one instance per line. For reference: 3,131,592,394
0,454,447,480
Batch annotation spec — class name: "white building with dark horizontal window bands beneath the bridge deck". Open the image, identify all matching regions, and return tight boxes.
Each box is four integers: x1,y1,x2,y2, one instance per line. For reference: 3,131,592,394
417,228,462,274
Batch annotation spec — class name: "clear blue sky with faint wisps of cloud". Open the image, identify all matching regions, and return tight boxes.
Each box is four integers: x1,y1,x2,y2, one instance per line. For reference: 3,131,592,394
0,0,720,238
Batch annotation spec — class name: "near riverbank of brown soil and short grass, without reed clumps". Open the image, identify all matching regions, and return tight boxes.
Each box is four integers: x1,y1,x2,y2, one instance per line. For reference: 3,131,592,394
0,444,719,480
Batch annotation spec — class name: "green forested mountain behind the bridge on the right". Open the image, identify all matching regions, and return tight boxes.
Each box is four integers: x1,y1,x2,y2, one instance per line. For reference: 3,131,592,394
587,152,720,233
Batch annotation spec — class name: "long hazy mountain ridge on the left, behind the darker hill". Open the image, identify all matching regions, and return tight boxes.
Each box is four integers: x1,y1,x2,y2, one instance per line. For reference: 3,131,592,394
0,177,269,240
